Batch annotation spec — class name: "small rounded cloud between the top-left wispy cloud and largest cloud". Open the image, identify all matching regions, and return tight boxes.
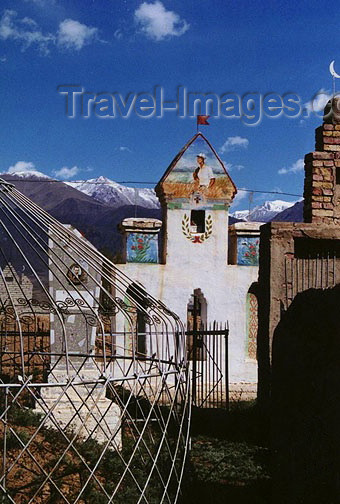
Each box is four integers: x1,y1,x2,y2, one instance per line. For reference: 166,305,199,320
58,19,98,51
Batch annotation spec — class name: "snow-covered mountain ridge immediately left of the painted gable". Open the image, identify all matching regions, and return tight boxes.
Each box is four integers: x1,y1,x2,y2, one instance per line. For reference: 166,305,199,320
65,176,160,208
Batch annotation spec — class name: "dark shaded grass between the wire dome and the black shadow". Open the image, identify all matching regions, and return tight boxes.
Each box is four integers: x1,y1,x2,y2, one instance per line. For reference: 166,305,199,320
181,401,271,504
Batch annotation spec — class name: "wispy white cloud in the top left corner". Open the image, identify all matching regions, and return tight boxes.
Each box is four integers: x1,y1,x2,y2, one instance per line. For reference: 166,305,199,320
0,9,55,54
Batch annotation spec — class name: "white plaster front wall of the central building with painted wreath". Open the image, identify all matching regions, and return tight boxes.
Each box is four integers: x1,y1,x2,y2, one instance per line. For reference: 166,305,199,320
118,205,258,383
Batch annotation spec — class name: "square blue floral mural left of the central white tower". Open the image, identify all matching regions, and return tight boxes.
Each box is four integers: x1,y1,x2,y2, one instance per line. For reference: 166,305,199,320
126,233,158,263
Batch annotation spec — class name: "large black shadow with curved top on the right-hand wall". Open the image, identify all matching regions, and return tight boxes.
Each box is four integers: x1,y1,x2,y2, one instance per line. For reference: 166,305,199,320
272,285,340,504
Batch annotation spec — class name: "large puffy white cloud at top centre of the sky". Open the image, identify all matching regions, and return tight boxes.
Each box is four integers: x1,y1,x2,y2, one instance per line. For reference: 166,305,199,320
135,1,190,42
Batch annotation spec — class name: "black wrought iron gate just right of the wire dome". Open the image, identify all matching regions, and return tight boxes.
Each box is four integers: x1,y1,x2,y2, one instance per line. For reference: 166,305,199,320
186,322,229,409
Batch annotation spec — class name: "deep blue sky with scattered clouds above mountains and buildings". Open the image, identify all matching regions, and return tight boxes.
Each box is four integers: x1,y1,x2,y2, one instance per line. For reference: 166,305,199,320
0,0,340,209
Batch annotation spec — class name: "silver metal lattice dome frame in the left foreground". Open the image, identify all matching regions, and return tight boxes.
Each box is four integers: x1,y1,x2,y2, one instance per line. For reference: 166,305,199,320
0,179,190,504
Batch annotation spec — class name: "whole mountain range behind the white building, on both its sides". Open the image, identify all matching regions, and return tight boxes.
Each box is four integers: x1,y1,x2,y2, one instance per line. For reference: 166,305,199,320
1,171,303,257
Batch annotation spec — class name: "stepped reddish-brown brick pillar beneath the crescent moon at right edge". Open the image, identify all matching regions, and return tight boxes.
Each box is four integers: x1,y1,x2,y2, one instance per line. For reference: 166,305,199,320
304,99,340,224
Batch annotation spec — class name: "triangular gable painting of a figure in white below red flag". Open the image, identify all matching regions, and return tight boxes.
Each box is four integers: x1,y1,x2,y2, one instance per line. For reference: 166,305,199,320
161,133,236,206
